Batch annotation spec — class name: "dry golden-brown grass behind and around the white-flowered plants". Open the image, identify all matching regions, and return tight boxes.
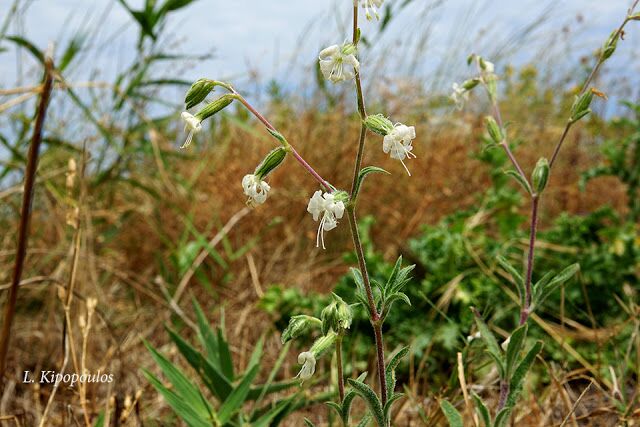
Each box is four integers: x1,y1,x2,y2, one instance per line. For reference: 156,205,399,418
0,83,625,426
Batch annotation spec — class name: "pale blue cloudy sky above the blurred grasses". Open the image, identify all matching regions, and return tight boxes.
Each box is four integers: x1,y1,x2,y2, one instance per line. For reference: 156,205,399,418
0,0,640,87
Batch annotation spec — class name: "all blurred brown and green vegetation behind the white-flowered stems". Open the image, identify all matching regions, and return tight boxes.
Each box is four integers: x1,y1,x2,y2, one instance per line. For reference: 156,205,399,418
0,0,640,425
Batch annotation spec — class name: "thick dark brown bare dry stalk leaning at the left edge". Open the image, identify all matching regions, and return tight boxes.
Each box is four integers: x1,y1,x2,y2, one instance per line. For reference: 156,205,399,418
0,58,53,390
